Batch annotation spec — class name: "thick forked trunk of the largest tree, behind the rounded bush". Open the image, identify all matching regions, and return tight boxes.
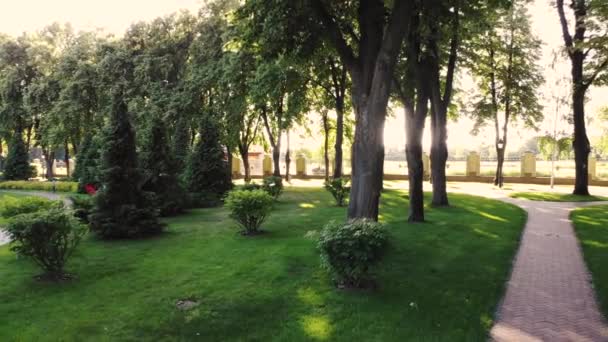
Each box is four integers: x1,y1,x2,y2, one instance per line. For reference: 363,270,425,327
311,0,412,220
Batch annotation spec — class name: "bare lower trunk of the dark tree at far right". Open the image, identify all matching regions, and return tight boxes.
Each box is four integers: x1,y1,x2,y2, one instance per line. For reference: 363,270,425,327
572,83,591,195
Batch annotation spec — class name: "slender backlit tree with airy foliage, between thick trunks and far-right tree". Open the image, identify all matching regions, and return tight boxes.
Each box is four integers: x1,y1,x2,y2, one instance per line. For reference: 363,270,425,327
468,1,544,187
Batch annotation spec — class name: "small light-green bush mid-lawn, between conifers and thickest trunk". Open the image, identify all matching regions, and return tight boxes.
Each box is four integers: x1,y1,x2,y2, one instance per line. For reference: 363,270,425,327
224,190,274,235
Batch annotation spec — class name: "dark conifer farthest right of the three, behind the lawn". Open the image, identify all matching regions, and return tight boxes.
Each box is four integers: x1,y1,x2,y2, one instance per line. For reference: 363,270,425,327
187,115,232,196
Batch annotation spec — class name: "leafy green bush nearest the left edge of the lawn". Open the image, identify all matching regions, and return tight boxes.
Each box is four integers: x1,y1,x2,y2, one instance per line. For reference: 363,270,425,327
4,208,87,280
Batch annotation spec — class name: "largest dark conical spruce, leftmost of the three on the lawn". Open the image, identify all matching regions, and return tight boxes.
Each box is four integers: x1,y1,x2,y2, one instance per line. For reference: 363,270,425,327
90,90,163,238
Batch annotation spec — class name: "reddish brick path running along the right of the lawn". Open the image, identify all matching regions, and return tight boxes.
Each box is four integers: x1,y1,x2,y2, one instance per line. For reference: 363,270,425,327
491,199,608,342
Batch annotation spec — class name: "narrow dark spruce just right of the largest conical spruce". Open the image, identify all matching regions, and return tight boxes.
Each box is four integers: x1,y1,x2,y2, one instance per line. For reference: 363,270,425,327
140,115,185,216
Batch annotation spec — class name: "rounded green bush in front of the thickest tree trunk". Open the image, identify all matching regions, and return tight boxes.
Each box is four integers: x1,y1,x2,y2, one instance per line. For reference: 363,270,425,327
318,220,388,288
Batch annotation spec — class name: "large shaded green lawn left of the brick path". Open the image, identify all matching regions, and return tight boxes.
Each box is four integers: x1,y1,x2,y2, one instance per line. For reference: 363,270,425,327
0,188,525,341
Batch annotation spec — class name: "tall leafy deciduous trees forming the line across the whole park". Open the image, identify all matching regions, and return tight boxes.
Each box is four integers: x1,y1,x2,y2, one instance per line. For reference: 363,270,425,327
0,0,608,221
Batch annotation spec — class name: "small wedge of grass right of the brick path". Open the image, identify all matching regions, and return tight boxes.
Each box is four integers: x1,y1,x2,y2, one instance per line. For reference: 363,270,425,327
570,205,608,314
